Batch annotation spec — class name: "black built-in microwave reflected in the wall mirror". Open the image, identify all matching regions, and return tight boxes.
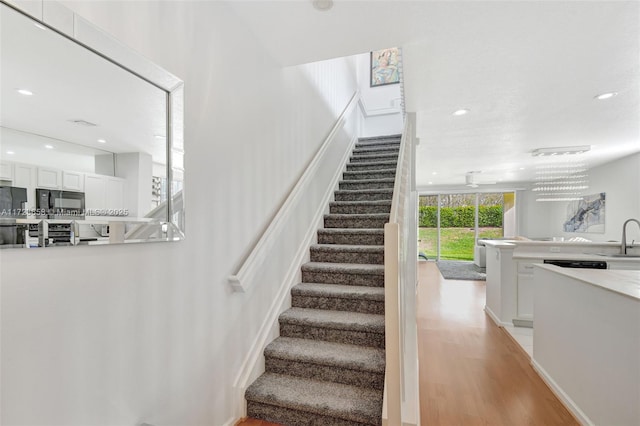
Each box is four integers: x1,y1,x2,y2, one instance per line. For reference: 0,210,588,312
36,188,84,220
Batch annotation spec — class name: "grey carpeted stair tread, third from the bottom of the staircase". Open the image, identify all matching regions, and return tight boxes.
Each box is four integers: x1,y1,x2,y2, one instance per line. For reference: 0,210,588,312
278,307,384,334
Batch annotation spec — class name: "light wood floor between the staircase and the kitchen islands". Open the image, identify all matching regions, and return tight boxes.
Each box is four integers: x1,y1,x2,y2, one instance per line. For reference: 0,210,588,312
238,262,578,426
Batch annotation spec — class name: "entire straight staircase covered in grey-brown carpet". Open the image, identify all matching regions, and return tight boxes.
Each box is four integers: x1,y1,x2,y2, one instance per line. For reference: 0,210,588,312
245,135,400,426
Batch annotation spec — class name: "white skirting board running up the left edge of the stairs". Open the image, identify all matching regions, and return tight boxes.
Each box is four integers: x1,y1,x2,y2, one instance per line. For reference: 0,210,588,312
230,137,357,420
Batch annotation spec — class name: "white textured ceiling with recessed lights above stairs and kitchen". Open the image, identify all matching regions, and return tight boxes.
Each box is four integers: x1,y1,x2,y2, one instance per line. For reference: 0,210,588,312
229,0,640,190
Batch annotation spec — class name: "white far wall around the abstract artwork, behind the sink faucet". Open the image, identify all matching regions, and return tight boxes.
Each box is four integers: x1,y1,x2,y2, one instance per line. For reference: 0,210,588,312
518,153,640,242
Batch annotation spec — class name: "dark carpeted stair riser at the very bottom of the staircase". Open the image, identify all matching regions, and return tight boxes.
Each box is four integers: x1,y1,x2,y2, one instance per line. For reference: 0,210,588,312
247,401,381,426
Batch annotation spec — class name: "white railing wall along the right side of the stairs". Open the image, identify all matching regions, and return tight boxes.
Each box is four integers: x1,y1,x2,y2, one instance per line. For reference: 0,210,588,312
382,113,419,426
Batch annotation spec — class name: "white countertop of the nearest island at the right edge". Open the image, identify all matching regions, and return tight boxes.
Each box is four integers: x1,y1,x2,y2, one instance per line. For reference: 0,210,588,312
535,264,640,301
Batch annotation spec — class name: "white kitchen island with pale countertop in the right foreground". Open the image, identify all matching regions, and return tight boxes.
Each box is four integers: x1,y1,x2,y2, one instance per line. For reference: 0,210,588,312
532,264,640,426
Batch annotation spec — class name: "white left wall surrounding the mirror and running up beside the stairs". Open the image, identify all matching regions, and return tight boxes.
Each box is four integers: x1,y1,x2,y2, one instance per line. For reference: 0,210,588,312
0,1,357,426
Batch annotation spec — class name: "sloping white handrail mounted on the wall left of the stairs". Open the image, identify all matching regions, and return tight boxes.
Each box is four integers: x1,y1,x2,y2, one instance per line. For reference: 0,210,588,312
228,91,360,292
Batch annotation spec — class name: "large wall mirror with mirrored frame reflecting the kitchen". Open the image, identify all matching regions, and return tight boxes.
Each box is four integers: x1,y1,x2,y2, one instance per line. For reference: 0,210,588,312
0,1,184,248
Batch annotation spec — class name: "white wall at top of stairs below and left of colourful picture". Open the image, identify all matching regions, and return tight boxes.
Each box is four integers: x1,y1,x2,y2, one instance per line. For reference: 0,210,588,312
356,53,404,136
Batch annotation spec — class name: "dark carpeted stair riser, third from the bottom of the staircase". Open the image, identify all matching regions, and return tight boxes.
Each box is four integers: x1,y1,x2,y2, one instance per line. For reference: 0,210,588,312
280,322,384,349
